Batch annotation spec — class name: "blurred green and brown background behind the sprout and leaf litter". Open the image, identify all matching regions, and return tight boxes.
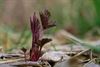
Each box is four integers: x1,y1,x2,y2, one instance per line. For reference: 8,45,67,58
0,0,100,51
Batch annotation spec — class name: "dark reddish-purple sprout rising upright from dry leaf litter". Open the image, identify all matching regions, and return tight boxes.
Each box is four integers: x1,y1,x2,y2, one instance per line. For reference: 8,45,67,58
30,10,55,61
